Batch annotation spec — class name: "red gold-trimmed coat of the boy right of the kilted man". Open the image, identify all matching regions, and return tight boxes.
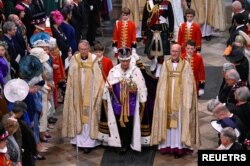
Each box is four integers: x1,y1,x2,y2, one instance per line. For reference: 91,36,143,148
177,22,202,53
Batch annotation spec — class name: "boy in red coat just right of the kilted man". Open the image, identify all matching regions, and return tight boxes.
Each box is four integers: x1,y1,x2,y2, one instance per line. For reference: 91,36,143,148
177,9,202,53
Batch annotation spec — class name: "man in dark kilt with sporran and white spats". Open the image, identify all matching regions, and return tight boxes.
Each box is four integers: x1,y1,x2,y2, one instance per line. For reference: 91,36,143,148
142,0,174,76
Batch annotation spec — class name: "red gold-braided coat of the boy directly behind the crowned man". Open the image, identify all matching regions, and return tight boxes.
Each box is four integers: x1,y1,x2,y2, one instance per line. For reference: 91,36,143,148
113,20,136,49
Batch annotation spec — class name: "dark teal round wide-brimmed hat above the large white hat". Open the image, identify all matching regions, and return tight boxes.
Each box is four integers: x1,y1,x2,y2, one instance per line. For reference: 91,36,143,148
19,55,43,81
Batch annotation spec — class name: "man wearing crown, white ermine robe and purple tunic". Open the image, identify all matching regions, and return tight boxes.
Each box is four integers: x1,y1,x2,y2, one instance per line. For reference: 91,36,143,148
99,48,149,153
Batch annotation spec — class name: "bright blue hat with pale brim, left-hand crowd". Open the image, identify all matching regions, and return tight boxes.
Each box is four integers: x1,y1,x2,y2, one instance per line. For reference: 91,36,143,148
30,32,50,47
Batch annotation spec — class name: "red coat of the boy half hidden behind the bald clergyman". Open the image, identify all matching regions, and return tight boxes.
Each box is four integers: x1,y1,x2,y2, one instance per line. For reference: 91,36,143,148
182,53,205,92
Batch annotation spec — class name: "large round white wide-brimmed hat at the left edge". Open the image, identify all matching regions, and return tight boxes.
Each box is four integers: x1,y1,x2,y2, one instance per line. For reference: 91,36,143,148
4,78,29,103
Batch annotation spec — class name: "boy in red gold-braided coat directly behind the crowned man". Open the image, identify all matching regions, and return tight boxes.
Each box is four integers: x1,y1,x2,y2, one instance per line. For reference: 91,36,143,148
112,7,136,60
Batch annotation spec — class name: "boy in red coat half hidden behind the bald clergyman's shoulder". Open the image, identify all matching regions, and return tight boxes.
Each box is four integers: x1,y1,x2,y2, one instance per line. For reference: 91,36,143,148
182,40,205,96
